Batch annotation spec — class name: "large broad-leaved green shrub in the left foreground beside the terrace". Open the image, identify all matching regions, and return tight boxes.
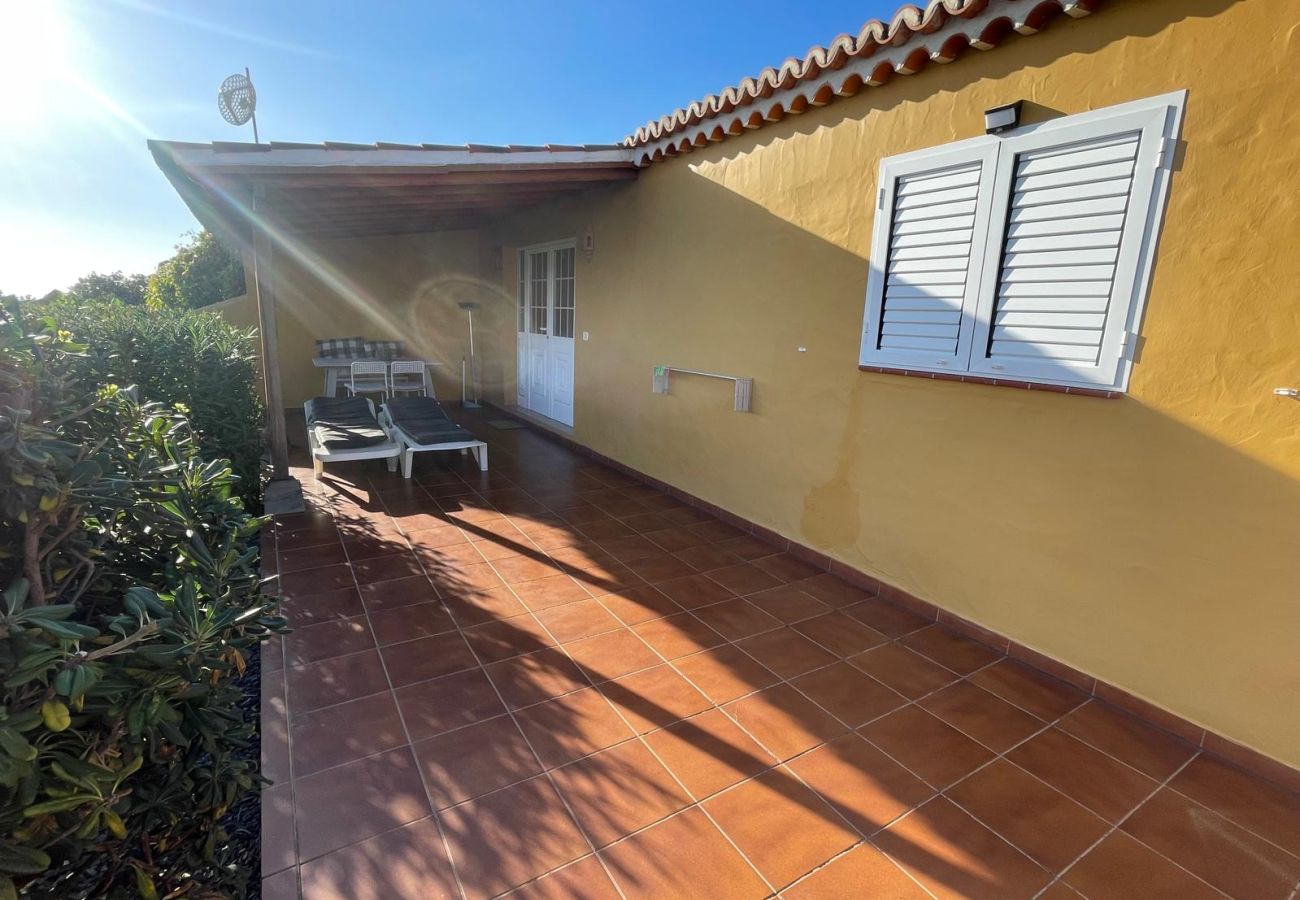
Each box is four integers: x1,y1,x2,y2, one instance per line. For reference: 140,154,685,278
0,299,283,899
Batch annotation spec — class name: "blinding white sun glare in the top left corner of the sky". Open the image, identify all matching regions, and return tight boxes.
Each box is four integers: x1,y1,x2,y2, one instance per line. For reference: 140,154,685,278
0,0,73,127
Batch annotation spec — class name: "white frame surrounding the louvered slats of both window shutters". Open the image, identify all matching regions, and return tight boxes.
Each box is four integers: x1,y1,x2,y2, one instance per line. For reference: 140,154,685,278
859,90,1187,391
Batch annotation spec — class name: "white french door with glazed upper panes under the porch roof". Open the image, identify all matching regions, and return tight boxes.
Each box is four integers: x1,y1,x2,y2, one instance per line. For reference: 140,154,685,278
517,241,577,425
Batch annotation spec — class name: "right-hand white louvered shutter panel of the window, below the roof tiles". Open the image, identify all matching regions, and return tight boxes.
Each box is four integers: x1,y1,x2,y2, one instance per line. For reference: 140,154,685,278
971,100,1185,386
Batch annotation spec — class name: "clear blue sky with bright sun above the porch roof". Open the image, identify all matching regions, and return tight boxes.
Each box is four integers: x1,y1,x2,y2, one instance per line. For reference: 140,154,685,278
0,0,897,295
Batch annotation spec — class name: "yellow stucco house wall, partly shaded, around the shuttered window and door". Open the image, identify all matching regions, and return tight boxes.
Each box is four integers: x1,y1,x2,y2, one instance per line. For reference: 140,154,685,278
220,0,1300,765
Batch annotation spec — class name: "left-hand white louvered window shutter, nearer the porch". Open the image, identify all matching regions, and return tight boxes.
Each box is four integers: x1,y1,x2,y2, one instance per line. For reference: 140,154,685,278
861,138,997,372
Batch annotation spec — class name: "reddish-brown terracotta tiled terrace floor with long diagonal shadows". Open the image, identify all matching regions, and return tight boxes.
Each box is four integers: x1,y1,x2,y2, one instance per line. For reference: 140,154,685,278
263,410,1300,900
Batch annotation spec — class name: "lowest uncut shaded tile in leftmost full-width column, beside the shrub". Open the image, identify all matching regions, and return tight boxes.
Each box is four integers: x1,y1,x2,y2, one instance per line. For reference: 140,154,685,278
294,747,432,861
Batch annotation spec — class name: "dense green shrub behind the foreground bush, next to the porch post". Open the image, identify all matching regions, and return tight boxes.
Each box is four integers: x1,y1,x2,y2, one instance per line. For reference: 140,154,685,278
38,300,263,512
